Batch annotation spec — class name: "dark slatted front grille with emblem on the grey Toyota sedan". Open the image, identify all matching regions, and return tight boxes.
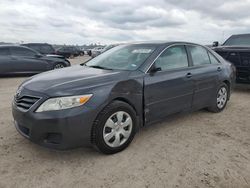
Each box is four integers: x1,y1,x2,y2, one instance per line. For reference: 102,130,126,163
14,96,40,111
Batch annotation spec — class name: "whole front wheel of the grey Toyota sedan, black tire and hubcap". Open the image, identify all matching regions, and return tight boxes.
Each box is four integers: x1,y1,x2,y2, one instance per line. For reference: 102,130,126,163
92,101,137,154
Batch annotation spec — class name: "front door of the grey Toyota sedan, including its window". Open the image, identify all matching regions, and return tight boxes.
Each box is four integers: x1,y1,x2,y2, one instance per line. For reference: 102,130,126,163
144,45,194,123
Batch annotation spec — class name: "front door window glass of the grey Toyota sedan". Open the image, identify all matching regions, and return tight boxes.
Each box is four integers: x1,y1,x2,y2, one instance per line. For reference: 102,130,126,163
155,46,188,71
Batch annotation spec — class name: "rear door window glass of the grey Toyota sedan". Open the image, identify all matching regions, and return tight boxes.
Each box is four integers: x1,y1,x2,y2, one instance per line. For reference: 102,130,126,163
189,46,210,65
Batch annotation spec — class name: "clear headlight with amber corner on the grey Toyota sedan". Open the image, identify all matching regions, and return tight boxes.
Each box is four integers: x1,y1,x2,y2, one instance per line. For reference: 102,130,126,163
36,94,92,112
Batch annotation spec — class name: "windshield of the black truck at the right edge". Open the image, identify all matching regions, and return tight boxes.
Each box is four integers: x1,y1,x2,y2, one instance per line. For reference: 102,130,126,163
223,35,250,46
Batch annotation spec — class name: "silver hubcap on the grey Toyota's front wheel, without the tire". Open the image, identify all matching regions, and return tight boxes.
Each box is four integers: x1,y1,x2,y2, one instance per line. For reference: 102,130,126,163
103,111,133,147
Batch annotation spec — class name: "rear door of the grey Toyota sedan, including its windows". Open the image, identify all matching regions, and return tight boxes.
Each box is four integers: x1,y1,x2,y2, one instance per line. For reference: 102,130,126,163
188,45,223,110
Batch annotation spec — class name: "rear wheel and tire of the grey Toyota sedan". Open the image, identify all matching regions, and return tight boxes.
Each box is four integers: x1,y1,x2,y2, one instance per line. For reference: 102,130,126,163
208,83,229,113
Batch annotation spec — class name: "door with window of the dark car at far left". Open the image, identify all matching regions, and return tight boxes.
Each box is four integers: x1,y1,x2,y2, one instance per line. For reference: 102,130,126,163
10,47,49,73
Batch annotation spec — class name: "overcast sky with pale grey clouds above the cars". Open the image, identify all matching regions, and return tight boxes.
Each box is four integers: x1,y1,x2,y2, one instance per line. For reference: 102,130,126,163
0,0,250,45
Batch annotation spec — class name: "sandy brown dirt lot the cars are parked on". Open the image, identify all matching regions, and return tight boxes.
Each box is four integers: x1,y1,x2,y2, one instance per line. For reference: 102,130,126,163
0,58,250,188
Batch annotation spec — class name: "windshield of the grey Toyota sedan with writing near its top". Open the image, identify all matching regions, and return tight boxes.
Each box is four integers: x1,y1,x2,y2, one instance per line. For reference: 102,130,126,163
85,44,155,70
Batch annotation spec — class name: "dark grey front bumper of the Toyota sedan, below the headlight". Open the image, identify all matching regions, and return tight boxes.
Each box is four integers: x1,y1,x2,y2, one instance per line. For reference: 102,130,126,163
12,98,95,150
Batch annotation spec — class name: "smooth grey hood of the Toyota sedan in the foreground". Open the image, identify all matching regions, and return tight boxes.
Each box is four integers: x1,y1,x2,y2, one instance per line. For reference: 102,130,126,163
22,65,128,95
